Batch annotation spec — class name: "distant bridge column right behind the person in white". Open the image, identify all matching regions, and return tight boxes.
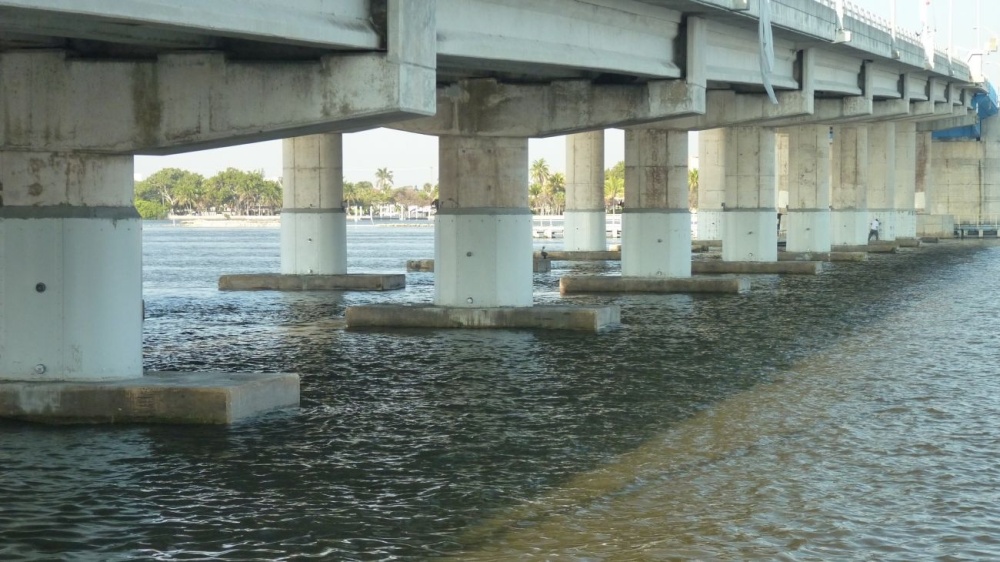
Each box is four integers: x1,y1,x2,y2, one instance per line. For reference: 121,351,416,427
866,123,896,241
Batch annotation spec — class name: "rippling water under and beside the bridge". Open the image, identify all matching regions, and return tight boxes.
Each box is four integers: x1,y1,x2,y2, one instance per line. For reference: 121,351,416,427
0,224,1000,561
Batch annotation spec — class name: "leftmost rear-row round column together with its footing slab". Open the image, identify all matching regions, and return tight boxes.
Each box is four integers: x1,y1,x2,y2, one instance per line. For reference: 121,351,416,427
219,133,406,291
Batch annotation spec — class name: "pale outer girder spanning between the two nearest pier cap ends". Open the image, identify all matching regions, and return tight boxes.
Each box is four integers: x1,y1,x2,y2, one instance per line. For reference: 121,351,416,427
437,0,682,79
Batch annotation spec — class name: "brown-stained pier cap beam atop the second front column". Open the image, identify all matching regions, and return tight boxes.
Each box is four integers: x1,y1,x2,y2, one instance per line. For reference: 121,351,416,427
390,79,705,137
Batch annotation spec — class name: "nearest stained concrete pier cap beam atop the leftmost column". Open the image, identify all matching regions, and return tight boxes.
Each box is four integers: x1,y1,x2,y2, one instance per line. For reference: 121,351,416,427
0,48,435,154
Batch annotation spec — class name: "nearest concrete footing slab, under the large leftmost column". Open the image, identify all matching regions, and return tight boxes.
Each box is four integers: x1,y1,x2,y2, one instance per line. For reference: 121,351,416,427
0,372,299,424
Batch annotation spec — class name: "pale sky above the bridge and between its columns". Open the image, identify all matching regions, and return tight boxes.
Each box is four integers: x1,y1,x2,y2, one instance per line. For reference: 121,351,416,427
135,0,1000,186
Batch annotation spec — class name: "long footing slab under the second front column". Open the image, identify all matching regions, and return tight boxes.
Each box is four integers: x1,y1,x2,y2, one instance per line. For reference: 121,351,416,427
347,304,621,332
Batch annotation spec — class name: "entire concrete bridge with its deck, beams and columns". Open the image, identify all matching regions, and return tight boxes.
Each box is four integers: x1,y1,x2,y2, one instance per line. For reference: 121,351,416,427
0,0,979,423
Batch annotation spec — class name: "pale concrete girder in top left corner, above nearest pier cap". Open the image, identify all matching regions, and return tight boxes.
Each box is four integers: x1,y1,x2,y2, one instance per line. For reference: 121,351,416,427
0,0,384,49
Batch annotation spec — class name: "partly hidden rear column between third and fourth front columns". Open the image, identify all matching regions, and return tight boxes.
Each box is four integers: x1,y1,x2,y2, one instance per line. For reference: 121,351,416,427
695,129,726,240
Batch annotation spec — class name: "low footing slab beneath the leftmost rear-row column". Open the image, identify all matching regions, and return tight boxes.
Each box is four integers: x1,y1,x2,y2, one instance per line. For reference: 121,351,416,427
219,273,406,291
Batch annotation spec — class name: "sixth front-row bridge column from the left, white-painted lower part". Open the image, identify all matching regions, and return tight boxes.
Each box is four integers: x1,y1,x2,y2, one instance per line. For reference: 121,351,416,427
830,125,869,246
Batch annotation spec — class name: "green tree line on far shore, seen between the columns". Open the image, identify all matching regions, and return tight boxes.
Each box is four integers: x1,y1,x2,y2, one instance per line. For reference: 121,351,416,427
135,158,698,219
